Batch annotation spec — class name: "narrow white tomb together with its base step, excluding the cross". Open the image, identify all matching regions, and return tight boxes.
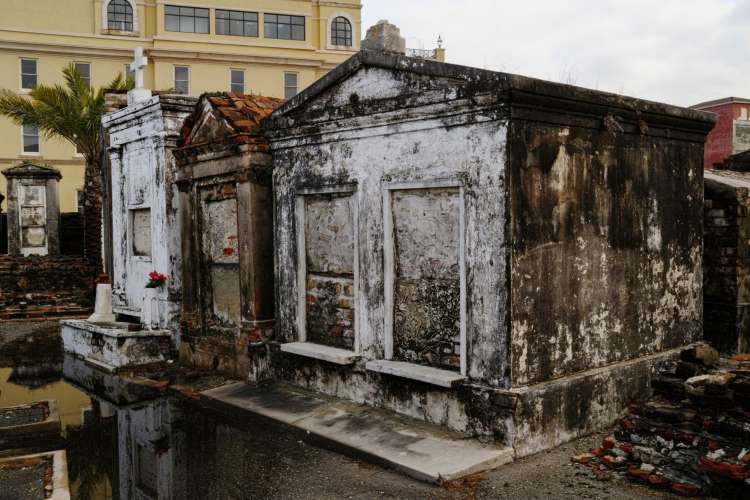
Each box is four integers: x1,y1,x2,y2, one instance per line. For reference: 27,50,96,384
61,95,196,370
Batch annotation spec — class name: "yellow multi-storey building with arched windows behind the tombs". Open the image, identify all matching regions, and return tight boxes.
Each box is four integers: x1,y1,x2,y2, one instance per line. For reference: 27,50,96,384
0,0,362,212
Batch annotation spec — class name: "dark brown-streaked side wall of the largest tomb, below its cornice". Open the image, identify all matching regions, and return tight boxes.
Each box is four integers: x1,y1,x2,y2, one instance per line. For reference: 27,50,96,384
511,122,703,385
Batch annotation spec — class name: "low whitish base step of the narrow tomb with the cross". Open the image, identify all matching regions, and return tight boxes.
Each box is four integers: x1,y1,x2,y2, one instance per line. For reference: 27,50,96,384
60,320,172,371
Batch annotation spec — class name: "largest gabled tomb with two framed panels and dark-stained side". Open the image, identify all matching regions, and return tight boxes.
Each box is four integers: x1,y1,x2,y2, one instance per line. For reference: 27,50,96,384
264,51,713,456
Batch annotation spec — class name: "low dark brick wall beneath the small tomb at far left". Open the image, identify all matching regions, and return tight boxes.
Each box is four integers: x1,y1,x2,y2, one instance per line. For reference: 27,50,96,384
0,255,94,320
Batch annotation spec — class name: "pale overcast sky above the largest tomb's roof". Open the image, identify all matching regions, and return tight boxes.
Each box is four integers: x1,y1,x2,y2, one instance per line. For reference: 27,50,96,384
362,0,750,106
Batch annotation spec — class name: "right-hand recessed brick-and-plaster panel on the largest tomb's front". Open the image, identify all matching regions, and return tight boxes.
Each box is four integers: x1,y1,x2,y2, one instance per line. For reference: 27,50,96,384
391,188,461,370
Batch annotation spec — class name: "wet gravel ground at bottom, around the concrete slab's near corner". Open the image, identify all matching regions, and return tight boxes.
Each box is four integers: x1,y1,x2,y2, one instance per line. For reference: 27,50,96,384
216,422,677,499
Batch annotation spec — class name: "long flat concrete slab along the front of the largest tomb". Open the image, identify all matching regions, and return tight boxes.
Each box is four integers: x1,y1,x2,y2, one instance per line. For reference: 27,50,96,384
201,382,513,483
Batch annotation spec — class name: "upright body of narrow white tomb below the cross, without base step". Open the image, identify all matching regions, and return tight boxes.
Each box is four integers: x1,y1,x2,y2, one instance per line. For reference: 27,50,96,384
102,95,196,331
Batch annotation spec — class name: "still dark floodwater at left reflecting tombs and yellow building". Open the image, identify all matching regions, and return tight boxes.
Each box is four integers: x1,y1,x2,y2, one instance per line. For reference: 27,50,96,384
0,326,306,500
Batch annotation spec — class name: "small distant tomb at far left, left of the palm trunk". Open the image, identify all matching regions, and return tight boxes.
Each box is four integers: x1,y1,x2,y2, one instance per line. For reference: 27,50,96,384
3,161,62,256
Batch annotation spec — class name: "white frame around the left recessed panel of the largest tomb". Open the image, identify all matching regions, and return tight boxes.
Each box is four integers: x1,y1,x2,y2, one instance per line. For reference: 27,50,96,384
295,184,362,355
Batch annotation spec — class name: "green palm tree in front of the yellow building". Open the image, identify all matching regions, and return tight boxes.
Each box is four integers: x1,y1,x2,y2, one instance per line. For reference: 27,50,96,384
0,64,132,272
